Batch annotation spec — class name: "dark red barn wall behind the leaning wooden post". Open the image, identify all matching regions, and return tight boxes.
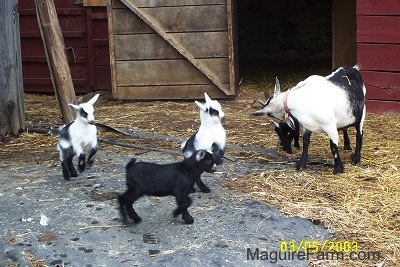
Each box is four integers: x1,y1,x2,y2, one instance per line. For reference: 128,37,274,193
18,0,111,94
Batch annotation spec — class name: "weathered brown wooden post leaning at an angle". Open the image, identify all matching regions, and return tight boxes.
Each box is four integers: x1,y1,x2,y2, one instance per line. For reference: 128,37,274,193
35,0,76,124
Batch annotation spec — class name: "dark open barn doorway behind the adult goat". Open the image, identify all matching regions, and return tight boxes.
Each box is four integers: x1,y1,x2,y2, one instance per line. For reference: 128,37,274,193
237,0,355,96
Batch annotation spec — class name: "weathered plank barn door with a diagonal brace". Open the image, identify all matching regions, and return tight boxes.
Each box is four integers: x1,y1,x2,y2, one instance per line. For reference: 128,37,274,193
108,0,237,99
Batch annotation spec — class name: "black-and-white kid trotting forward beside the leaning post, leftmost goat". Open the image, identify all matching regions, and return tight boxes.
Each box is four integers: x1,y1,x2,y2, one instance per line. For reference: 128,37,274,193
57,94,99,180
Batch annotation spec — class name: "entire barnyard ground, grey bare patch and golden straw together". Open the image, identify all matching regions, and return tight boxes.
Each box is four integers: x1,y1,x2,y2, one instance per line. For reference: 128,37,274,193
0,79,400,266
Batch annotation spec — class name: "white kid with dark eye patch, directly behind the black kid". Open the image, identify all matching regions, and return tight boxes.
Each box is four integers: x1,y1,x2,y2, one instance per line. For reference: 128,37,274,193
181,93,226,193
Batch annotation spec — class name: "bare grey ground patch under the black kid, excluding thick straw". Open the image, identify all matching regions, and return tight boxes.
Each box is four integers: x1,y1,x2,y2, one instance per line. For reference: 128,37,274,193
0,141,330,266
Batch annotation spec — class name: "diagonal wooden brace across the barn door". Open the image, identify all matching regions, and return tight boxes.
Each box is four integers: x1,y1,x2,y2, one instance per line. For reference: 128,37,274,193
117,0,234,96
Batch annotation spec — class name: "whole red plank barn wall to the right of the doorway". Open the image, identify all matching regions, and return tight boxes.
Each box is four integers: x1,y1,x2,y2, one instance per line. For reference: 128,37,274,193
356,0,400,113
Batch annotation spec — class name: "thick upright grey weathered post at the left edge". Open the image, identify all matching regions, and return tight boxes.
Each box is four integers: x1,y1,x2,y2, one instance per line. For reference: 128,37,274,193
0,0,25,136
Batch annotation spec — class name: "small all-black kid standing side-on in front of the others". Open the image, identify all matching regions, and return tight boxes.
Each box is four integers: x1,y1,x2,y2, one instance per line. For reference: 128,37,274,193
118,150,214,224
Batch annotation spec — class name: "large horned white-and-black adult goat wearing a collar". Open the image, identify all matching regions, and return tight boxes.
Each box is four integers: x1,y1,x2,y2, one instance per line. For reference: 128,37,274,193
252,66,366,174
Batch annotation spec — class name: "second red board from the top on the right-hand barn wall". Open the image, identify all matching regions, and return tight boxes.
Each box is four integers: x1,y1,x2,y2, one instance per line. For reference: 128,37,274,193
357,15,400,44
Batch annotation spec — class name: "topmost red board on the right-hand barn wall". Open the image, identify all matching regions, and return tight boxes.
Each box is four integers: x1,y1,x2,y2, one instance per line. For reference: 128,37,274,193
356,0,400,15
